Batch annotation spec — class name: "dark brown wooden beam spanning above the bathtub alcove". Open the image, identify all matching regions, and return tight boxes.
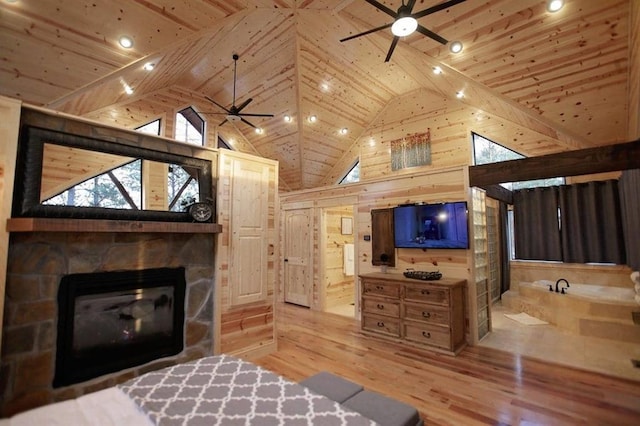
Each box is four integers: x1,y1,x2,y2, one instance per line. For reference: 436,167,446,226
469,139,640,187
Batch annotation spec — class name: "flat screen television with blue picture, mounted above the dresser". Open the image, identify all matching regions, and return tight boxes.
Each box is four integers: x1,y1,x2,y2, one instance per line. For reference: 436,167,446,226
393,201,469,249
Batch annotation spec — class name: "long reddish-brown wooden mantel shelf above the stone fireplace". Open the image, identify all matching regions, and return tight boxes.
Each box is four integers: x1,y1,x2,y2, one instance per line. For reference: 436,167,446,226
7,218,222,234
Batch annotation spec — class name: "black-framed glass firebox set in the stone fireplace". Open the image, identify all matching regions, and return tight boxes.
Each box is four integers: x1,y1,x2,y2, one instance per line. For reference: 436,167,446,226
53,267,186,387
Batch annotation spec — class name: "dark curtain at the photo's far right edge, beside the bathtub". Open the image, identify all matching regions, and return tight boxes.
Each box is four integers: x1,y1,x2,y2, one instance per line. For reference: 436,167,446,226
618,169,640,271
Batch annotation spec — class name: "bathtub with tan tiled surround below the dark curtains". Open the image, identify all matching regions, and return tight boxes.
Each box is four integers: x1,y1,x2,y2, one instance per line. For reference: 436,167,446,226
502,280,640,343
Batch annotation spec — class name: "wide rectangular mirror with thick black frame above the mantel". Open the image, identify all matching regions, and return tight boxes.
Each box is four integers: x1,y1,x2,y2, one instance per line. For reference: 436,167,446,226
12,115,213,222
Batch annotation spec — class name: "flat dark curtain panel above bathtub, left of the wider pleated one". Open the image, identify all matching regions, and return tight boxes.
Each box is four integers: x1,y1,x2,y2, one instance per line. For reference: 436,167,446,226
513,187,562,261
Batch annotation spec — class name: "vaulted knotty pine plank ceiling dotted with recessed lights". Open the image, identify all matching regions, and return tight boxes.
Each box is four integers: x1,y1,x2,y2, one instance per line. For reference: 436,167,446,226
0,0,635,189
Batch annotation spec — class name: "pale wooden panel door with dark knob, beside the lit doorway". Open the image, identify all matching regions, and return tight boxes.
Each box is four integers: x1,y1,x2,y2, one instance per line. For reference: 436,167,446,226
284,208,313,307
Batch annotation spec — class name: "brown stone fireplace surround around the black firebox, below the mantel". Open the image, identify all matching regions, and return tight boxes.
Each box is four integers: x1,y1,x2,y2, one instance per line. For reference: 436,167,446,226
0,228,215,416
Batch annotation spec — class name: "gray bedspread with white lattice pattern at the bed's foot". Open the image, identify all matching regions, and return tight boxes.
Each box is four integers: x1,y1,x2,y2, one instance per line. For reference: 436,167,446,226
119,355,375,426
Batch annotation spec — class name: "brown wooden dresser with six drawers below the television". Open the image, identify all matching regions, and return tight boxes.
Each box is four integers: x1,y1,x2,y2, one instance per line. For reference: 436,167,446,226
360,273,466,355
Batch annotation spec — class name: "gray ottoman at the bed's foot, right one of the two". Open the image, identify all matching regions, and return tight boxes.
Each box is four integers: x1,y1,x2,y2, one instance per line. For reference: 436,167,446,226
342,390,423,426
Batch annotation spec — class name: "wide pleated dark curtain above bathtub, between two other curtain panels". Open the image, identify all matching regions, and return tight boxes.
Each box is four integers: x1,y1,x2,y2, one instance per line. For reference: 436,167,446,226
559,180,626,264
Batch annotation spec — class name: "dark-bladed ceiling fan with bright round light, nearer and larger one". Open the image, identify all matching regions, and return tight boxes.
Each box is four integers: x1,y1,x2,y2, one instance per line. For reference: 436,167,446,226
340,0,466,62
